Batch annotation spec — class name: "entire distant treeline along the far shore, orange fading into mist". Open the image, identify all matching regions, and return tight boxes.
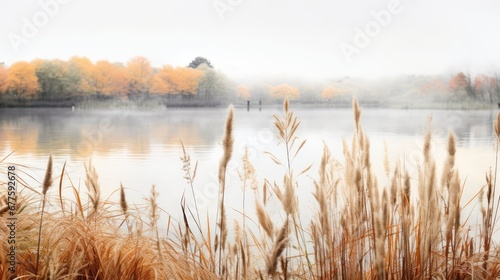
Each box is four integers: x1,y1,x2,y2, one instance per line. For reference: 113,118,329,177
0,56,500,107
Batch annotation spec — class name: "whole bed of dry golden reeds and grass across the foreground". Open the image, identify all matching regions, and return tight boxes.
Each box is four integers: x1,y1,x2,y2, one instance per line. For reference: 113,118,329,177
0,99,500,279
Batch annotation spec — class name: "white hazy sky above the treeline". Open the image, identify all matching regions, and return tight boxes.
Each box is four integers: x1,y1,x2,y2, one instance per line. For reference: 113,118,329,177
0,0,500,79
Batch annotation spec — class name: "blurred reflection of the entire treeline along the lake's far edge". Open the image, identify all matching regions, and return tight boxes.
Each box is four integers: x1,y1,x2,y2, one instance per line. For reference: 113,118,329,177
0,109,494,158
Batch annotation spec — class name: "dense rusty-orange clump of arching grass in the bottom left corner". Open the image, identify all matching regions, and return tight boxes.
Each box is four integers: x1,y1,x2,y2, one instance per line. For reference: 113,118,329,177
10,200,217,279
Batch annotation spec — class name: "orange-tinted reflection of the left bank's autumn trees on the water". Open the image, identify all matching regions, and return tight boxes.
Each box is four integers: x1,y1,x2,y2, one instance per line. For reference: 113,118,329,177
0,109,225,158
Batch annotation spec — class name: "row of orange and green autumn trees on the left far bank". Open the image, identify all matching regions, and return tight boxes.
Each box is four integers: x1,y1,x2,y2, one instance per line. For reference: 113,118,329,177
0,56,211,101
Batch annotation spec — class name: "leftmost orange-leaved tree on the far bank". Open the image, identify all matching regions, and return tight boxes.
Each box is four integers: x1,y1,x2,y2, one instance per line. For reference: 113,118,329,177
7,61,40,99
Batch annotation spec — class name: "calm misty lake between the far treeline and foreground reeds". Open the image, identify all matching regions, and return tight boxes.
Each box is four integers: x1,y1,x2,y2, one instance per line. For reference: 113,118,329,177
0,104,496,229
